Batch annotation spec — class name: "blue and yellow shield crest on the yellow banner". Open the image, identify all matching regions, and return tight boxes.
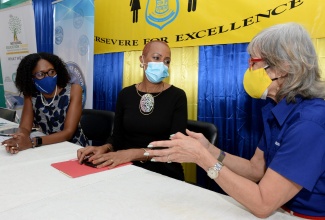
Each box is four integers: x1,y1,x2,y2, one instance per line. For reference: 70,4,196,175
145,0,179,30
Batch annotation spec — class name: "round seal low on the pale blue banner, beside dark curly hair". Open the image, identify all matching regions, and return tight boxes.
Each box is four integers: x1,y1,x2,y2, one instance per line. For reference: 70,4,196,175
66,61,87,107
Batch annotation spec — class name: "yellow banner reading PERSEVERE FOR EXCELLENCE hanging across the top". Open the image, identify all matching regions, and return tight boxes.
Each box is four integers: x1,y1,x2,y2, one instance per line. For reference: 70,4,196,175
94,0,325,54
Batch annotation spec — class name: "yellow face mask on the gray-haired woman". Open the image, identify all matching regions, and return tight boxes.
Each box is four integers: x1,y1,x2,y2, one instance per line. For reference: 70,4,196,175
243,66,273,99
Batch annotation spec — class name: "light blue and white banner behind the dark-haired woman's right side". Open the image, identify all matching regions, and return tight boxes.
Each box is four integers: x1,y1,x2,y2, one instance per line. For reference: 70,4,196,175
54,0,94,108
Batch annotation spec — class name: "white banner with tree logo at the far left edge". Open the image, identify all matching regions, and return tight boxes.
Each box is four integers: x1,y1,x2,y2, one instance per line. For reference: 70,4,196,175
0,2,37,115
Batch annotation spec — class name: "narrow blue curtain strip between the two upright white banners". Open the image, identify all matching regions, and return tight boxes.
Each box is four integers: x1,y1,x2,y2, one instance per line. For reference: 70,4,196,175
33,0,54,53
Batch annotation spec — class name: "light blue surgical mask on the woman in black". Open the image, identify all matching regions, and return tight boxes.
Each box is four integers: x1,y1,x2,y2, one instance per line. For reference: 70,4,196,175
145,62,169,83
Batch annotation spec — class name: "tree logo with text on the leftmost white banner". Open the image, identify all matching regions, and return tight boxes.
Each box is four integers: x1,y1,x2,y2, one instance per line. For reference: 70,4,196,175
6,15,29,55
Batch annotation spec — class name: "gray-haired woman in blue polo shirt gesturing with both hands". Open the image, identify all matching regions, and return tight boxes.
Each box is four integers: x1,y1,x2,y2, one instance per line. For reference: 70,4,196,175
148,23,325,219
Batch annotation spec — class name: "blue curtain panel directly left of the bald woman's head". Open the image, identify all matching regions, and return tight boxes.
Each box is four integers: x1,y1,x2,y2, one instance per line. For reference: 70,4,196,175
93,52,124,111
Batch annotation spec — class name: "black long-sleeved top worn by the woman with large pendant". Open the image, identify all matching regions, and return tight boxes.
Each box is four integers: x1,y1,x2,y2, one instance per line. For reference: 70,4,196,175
107,85,187,180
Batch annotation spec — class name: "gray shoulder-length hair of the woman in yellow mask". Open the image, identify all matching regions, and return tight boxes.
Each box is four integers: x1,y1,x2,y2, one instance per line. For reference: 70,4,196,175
247,23,325,103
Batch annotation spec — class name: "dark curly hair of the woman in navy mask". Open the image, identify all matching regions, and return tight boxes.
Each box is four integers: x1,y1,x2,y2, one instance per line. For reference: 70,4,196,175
15,52,70,96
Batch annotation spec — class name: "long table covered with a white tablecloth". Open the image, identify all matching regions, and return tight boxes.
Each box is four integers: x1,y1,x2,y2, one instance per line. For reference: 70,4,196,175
0,142,296,220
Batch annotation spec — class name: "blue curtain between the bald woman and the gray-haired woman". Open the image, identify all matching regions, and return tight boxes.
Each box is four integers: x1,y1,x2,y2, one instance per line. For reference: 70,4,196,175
197,43,265,192
